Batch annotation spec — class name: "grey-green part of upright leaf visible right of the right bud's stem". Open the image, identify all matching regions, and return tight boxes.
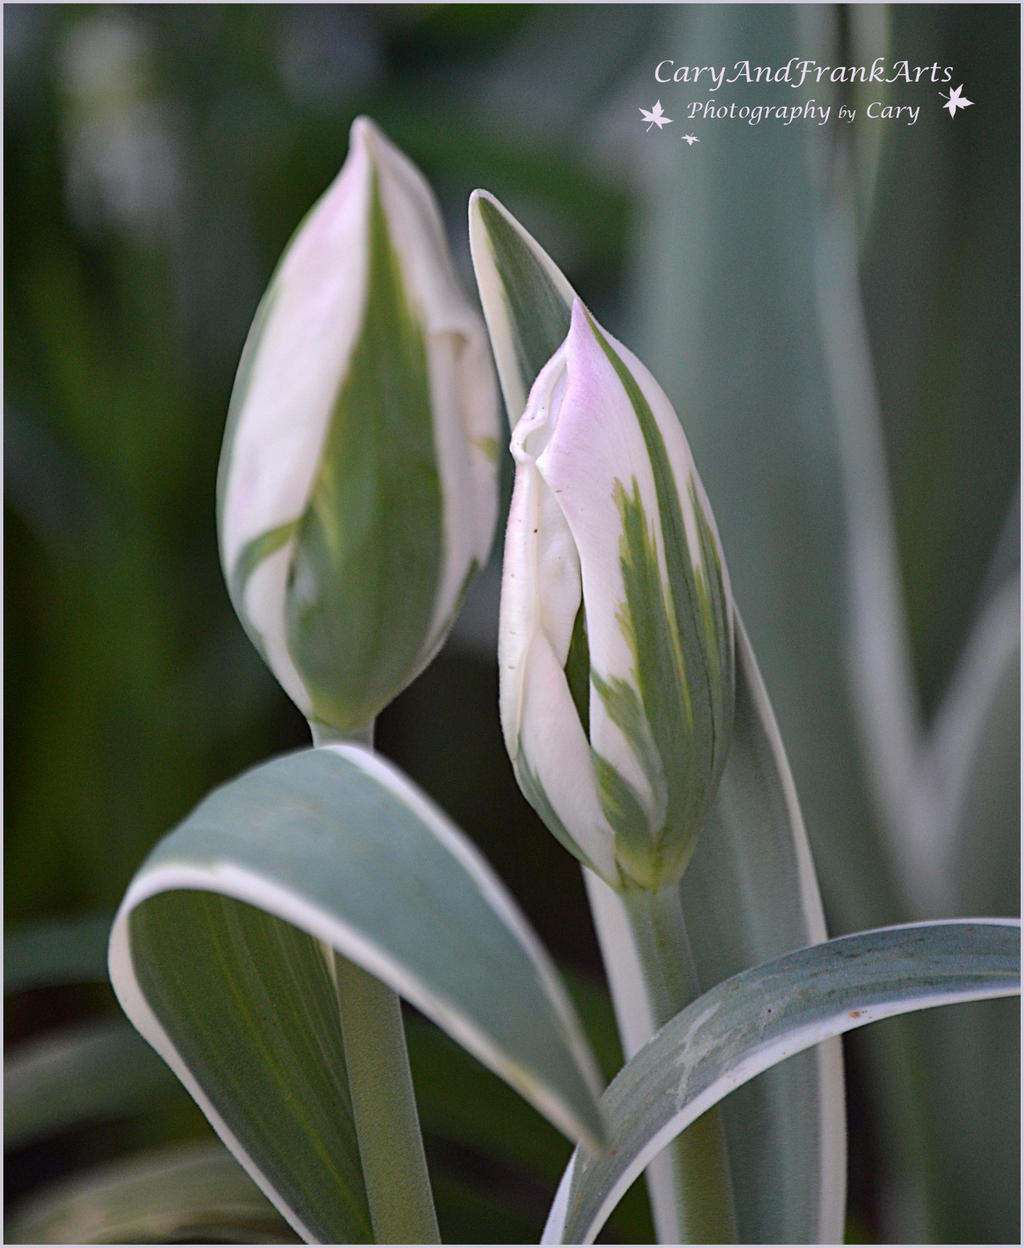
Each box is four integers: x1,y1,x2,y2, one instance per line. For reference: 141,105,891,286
680,622,846,1243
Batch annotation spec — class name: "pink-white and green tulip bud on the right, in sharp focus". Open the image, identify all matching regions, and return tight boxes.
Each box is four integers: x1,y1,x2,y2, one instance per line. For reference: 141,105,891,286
499,300,733,891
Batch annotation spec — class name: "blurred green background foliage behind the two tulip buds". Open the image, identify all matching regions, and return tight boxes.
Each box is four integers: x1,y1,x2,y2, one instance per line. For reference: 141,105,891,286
4,4,1020,1242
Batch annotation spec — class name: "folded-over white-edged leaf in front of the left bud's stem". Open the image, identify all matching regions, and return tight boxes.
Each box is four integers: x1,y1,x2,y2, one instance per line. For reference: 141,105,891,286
110,746,601,1242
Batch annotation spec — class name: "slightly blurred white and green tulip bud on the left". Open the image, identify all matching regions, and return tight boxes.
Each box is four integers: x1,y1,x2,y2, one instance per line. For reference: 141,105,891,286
217,119,499,735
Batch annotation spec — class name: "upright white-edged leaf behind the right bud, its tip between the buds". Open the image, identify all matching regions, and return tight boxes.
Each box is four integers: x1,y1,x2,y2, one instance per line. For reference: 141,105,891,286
470,192,846,1242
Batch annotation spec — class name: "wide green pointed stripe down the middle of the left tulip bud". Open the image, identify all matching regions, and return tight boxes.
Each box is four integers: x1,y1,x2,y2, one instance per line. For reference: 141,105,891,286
287,165,443,731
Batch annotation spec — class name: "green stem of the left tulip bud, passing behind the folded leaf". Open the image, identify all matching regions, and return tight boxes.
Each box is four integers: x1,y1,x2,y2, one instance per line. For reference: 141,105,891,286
309,721,440,1244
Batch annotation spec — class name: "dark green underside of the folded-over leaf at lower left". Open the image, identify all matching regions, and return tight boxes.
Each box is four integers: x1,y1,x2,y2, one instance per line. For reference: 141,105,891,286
121,893,373,1243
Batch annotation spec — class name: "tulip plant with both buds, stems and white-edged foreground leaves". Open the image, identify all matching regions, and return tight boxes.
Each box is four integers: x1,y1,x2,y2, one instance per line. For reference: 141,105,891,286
110,120,1019,1243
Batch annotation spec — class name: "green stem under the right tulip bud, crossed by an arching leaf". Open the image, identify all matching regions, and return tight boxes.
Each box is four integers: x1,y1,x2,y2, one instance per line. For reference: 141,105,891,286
621,887,737,1244
